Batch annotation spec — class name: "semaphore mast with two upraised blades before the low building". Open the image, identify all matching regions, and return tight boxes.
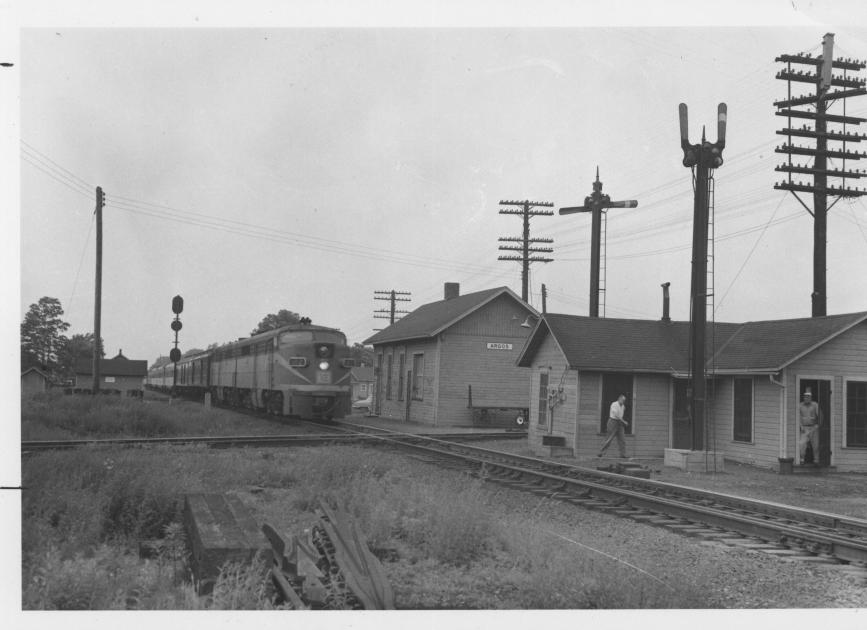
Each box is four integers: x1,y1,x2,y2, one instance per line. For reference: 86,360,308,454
680,103,728,451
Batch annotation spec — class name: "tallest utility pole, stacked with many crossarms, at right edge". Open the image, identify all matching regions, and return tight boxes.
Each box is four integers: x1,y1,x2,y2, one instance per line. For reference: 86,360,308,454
774,33,867,317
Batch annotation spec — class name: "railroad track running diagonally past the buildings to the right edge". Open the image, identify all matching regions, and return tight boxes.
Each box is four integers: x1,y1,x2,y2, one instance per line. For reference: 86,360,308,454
318,425,867,580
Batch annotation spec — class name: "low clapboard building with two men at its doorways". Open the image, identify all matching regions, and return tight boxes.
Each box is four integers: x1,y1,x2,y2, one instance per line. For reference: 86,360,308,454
518,313,867,472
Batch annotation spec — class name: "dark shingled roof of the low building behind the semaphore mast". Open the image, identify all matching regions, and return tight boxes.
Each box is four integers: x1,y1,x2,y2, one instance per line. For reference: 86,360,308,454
517,312,867,374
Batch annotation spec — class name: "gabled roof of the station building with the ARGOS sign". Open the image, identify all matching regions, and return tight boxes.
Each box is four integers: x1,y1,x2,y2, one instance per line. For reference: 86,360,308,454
364,287,538,345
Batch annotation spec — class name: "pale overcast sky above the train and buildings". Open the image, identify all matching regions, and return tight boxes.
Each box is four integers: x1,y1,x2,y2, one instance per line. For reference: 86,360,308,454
14,2,867,370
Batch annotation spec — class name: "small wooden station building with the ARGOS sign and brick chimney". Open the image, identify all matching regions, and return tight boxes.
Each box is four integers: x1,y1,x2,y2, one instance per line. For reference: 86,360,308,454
364,282,538,425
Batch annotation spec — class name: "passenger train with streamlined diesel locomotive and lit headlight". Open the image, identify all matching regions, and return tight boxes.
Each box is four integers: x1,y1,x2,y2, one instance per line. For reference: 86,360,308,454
147,323,355,420
